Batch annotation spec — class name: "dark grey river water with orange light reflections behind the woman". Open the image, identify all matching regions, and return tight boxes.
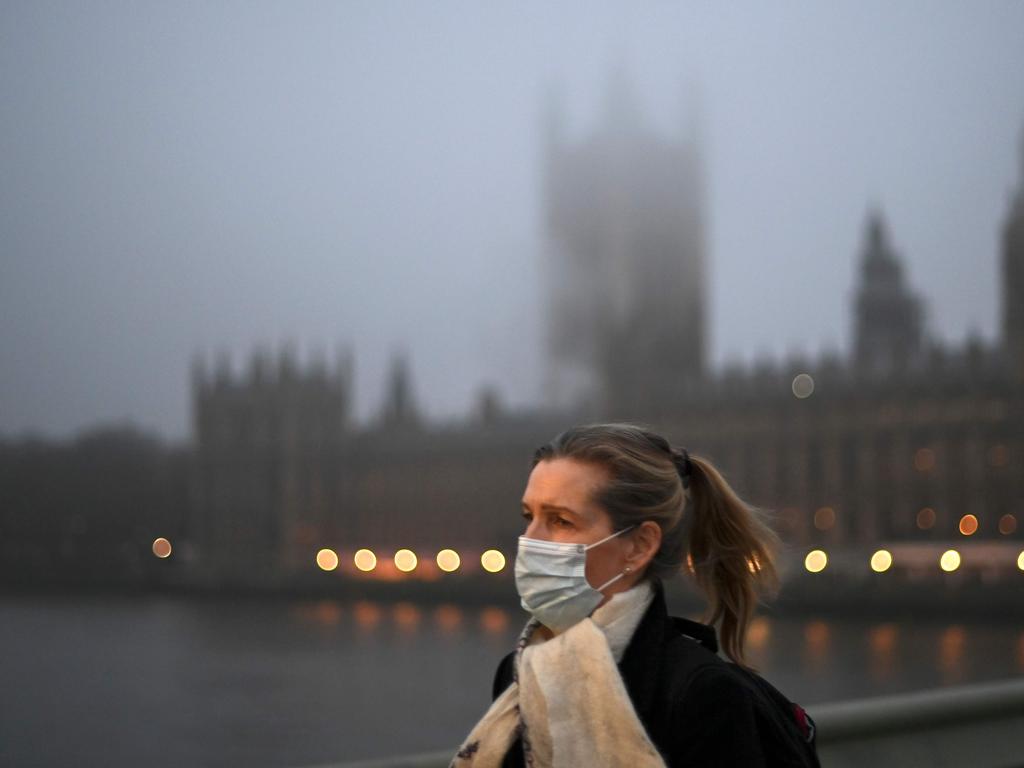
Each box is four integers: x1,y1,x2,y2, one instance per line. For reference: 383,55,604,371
0,597,1024,766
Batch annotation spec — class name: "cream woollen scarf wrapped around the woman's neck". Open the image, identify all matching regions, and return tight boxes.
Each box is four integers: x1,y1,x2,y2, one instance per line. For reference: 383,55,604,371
450,582,665,768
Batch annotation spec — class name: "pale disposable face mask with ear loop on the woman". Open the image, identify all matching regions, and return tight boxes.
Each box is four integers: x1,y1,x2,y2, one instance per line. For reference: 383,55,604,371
515,525,636,633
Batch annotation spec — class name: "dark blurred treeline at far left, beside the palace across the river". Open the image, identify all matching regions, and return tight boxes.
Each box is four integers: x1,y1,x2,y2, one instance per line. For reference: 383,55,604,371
0,425,190,590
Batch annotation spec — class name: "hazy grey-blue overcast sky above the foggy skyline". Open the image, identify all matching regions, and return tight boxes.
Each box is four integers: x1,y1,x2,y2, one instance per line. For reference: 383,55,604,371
0,0,1024,438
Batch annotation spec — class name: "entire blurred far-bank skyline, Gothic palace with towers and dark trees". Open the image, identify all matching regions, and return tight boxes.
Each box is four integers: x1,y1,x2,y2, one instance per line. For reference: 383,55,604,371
0,85,1024,584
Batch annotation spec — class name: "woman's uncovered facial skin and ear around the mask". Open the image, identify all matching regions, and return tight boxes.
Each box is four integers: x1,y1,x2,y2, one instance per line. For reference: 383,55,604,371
522,459,638,597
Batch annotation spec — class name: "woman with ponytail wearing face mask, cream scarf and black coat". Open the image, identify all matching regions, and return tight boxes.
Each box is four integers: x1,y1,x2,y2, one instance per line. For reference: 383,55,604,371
452,424,817,768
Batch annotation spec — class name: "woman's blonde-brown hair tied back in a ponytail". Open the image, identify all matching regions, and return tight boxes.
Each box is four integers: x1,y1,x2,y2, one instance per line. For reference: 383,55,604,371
532,424,779,668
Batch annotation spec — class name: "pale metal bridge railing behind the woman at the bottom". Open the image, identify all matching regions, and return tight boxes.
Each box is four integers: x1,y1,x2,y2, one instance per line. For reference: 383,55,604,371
316,677,1024,768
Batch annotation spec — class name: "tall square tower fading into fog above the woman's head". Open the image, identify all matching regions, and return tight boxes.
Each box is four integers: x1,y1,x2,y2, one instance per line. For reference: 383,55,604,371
544,73,707,418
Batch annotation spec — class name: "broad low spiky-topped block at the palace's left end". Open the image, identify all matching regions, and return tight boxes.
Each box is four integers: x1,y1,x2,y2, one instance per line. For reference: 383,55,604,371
188,347,352,582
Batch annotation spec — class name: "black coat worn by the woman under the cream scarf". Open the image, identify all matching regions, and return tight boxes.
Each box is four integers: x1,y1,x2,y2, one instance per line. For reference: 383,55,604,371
493,585,819,768
